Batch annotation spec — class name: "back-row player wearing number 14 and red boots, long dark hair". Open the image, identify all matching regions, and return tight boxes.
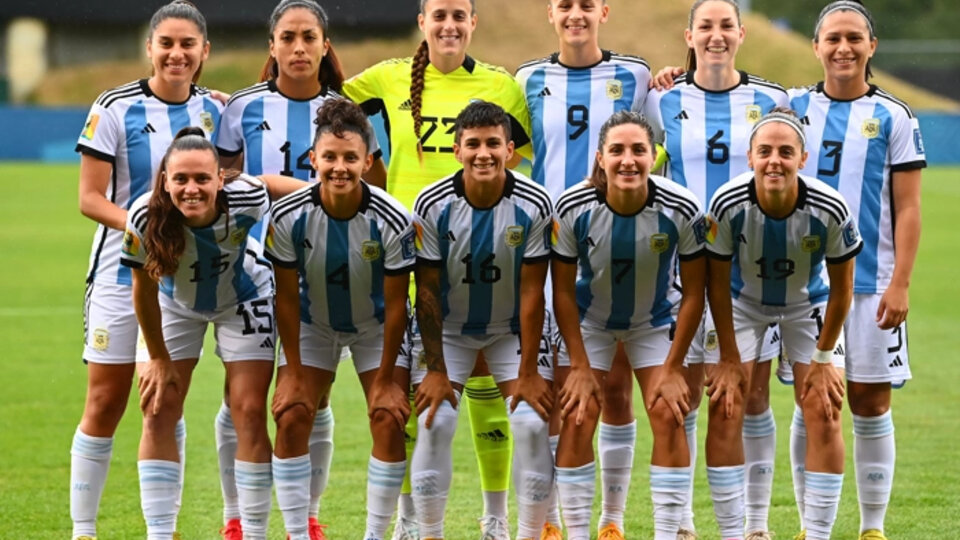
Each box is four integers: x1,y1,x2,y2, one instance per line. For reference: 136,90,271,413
214,0,384,540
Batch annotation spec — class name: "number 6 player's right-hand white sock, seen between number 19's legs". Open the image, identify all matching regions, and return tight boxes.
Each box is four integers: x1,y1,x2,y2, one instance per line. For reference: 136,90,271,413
743,407,777,533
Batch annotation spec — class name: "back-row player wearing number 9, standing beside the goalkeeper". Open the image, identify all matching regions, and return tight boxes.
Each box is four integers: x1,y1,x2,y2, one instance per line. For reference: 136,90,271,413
517,4,650,540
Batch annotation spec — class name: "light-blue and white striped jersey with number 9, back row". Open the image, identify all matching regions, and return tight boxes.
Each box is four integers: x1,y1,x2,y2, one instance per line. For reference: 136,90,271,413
517,51,650,201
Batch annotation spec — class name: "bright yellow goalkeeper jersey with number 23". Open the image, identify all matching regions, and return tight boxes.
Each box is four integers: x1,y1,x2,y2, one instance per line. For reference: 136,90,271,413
343,56,531,209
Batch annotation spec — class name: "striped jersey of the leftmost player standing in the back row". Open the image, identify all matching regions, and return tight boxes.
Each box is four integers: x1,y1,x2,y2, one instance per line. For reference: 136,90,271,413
76,79,223,285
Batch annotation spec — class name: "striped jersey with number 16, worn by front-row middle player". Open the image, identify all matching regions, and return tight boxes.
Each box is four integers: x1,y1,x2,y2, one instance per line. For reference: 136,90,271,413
414,170,553,335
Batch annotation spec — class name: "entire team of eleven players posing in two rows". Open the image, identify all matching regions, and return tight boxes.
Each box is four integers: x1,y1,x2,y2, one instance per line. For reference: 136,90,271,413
62,0,927,540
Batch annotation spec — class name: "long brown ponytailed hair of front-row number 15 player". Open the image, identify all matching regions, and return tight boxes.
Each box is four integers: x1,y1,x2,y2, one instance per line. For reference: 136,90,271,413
143,126,239,280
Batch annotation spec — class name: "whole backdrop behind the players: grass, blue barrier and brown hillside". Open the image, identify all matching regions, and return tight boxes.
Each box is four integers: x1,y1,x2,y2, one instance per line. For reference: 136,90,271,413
0,0,960,540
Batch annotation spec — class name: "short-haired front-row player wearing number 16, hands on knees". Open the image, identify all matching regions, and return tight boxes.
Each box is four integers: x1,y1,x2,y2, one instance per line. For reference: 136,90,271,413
410,101,553,539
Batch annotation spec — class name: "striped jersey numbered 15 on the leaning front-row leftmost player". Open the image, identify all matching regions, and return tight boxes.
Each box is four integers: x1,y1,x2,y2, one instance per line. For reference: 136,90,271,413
121,175,274,312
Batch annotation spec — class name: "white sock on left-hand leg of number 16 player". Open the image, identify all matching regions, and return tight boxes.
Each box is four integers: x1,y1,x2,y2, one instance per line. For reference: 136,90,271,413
410,394,460,538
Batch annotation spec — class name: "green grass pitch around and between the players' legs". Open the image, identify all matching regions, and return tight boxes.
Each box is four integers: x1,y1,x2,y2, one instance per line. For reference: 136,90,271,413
0,164,960,540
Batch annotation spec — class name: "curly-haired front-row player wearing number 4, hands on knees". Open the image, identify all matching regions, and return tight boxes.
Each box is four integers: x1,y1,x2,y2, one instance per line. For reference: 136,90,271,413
267,99,416,540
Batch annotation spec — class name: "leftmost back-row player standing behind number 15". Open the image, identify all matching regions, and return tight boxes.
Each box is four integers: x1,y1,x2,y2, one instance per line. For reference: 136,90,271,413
70,0,221,539
